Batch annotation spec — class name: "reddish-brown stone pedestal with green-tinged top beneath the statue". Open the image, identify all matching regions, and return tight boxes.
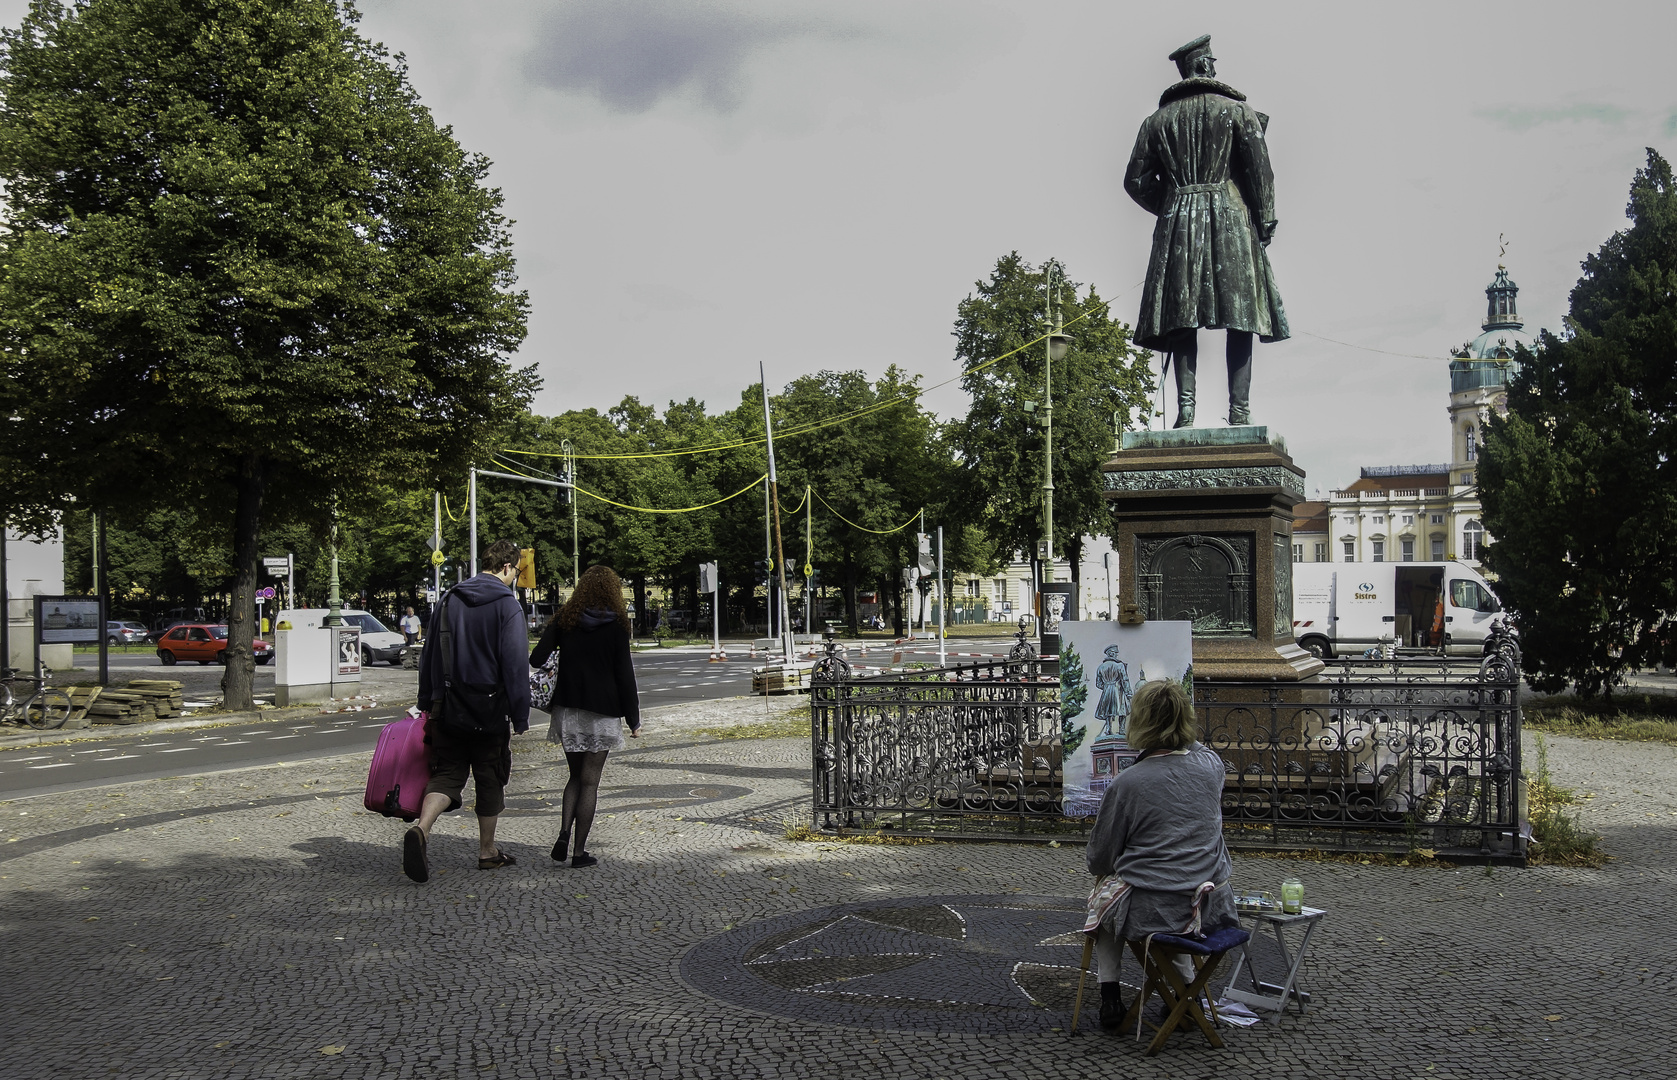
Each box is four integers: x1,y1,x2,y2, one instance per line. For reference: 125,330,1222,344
1102,426,1323,681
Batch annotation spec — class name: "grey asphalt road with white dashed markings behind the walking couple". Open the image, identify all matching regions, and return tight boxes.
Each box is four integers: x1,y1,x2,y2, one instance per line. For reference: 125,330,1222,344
13,639,1011,798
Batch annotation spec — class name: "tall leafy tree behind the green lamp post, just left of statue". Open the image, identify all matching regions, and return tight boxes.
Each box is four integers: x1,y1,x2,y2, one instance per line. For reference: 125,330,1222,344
951,252,1154,582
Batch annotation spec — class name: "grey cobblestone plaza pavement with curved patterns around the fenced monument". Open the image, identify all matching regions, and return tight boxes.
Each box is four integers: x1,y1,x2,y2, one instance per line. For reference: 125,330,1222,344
0,707,1677,1080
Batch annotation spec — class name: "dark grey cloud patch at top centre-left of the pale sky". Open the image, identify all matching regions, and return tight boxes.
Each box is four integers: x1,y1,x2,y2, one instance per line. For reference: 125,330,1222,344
525,0,842,112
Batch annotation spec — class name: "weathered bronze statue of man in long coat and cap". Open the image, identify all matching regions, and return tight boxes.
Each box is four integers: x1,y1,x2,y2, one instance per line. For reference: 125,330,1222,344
1124,34,1288,428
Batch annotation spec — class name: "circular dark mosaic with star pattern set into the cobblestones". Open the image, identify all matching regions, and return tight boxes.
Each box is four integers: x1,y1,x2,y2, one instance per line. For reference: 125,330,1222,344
681,896,1095,1031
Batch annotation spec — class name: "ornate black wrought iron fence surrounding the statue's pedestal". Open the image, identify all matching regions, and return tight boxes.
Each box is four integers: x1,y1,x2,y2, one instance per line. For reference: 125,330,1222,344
810,642,1524,859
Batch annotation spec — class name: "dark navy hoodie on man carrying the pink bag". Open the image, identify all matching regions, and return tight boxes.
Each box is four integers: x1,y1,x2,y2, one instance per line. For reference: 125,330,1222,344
419,574,530,735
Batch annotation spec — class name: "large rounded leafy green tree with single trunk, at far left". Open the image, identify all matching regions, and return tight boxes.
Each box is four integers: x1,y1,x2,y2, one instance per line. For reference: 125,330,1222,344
0,0,535,708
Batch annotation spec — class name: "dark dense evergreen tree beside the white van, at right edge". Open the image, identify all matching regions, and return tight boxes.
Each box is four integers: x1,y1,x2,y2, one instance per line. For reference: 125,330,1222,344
1479,149,1677,696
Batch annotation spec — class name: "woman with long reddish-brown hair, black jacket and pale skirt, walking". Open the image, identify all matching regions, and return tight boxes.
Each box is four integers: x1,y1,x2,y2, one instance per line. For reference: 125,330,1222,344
530,567,641,867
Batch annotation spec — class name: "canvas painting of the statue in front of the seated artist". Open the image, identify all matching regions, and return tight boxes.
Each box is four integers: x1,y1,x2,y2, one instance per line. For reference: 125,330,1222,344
1060,620,1194,818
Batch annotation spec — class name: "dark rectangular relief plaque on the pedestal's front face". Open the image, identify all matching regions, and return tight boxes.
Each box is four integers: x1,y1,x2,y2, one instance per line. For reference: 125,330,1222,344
1135,533,1254,637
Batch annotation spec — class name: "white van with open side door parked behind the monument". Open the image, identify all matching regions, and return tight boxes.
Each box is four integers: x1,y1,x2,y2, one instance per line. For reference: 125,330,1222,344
1293,562,1503,659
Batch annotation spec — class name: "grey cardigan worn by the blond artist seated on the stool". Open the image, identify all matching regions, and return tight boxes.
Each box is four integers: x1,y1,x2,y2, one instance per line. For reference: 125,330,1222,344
1087,743,1238,937
